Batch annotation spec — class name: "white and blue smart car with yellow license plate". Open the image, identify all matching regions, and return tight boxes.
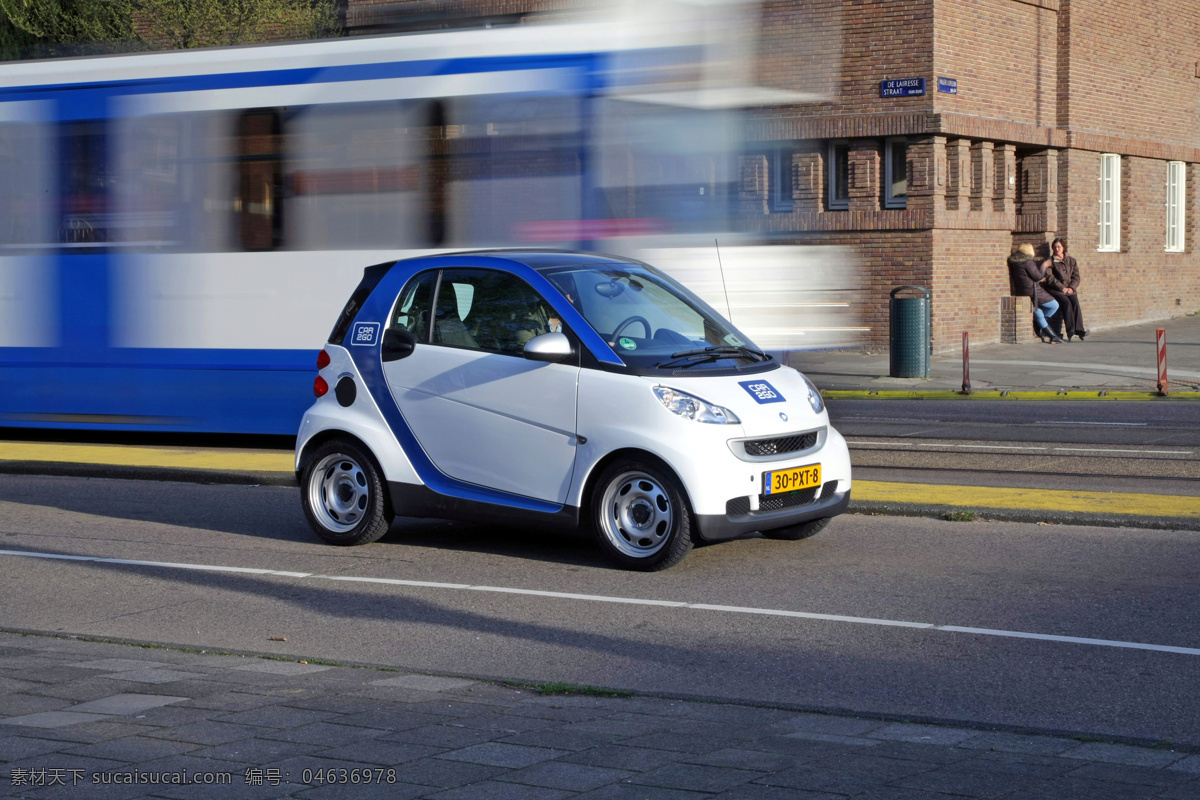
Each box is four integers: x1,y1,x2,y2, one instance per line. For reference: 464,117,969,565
296,251,850,570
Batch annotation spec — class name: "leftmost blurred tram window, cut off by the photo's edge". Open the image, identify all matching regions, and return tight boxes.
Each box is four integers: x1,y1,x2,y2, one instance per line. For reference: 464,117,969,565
0,122,54,247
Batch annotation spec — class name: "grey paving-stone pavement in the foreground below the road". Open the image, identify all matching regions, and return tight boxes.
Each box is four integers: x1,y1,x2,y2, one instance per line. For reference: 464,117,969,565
0,633,1200,800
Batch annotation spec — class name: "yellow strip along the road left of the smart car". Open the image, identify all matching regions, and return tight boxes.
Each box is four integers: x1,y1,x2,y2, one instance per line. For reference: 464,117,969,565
0,441,295,473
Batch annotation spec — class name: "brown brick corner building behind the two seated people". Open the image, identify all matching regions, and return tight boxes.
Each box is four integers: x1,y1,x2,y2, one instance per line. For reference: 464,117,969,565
743,0,1200,350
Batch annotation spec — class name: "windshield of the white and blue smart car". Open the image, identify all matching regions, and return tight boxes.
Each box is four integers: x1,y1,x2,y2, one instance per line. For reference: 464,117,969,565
542,264,769,369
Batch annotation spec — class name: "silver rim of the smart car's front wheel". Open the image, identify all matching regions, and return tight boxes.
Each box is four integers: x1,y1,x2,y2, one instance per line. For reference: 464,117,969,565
600,470,674,558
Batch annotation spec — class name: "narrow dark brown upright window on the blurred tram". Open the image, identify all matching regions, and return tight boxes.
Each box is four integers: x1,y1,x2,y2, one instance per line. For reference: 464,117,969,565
234,109,283,249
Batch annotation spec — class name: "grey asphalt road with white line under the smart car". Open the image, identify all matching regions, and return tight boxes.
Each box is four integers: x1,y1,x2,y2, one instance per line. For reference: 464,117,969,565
0,476,1200,746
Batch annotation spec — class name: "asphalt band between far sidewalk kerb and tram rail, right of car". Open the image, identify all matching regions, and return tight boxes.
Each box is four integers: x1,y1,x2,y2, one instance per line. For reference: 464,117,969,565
829,399,1200,443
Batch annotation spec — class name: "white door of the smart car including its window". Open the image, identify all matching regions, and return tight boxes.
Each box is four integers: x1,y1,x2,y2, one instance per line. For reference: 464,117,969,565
383,269,580,503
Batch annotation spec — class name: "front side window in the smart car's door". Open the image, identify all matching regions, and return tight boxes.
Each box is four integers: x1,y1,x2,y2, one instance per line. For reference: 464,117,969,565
433,269,557,355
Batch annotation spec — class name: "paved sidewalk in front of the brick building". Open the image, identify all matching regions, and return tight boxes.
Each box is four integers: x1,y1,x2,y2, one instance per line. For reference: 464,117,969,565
788,314,1200,399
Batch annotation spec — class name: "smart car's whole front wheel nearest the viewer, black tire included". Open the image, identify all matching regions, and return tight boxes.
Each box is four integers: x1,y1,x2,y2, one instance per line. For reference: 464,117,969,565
592,459,692,572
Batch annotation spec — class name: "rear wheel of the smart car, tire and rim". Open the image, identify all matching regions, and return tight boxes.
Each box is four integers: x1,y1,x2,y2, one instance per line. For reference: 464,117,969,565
300,439,394,547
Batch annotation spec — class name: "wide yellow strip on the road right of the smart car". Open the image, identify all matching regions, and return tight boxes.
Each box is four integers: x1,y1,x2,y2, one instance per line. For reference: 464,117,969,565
852,481,1200,518
